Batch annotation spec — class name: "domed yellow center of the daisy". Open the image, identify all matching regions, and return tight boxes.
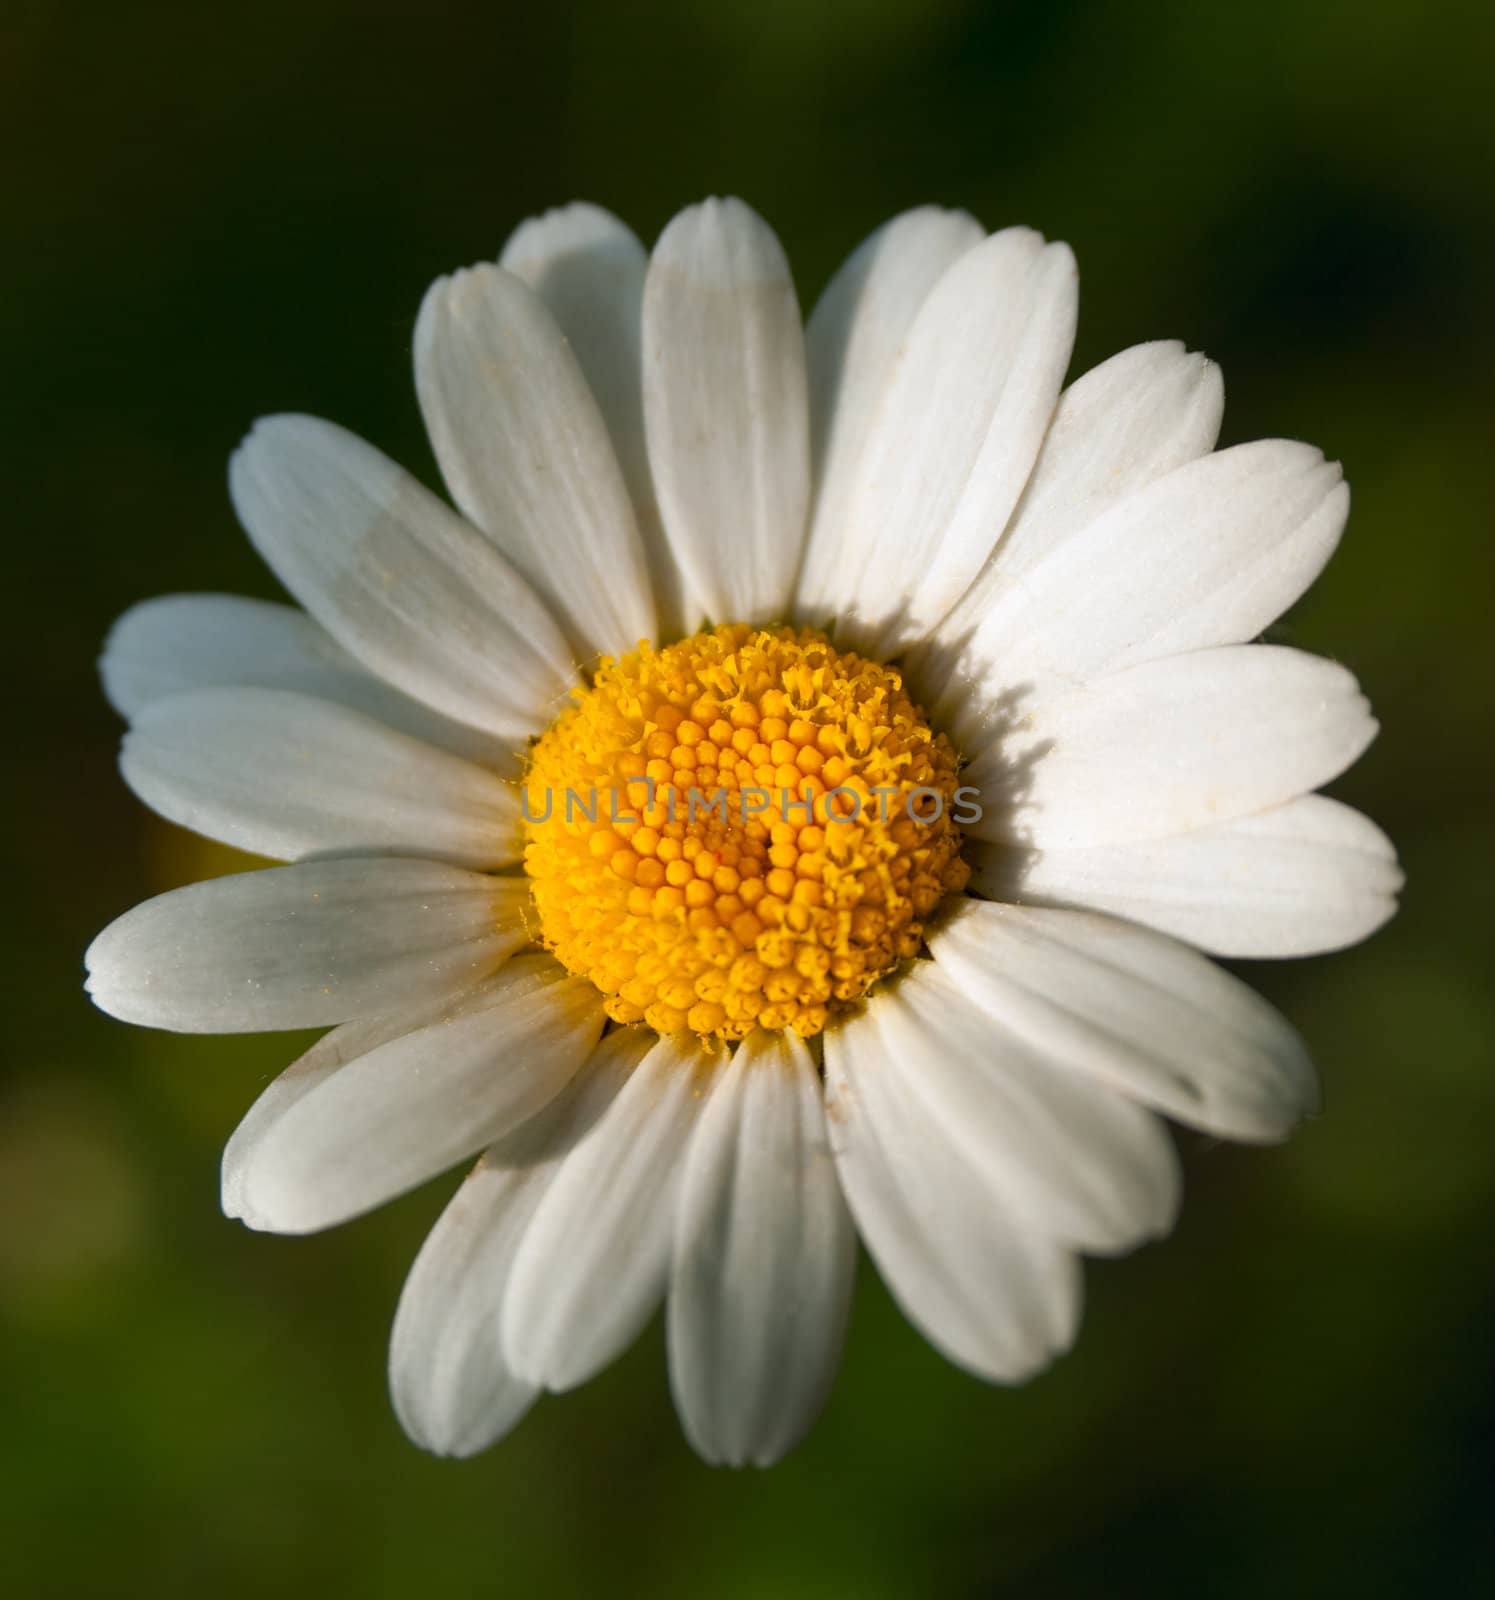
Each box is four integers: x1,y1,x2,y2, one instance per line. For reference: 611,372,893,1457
525,624,968,1040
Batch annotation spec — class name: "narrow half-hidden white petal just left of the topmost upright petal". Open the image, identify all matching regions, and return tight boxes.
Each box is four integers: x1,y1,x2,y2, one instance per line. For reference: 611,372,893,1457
499,203,691,638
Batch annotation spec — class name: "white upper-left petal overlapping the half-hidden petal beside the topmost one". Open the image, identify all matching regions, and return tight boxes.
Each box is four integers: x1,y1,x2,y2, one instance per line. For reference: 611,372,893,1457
415,266,655,659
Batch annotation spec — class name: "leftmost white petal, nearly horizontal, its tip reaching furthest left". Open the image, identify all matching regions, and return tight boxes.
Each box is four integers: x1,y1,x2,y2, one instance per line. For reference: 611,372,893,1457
83,858,528,1034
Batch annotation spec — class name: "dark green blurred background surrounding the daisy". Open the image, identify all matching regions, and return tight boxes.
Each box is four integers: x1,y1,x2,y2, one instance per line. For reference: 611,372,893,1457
0,0,1495,1600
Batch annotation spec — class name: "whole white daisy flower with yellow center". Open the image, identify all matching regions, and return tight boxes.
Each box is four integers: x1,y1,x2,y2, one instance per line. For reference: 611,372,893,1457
88,200,1399,1462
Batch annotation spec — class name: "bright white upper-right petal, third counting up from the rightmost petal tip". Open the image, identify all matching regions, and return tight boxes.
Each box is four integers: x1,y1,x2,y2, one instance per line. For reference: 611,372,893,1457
960,438,1349,699
